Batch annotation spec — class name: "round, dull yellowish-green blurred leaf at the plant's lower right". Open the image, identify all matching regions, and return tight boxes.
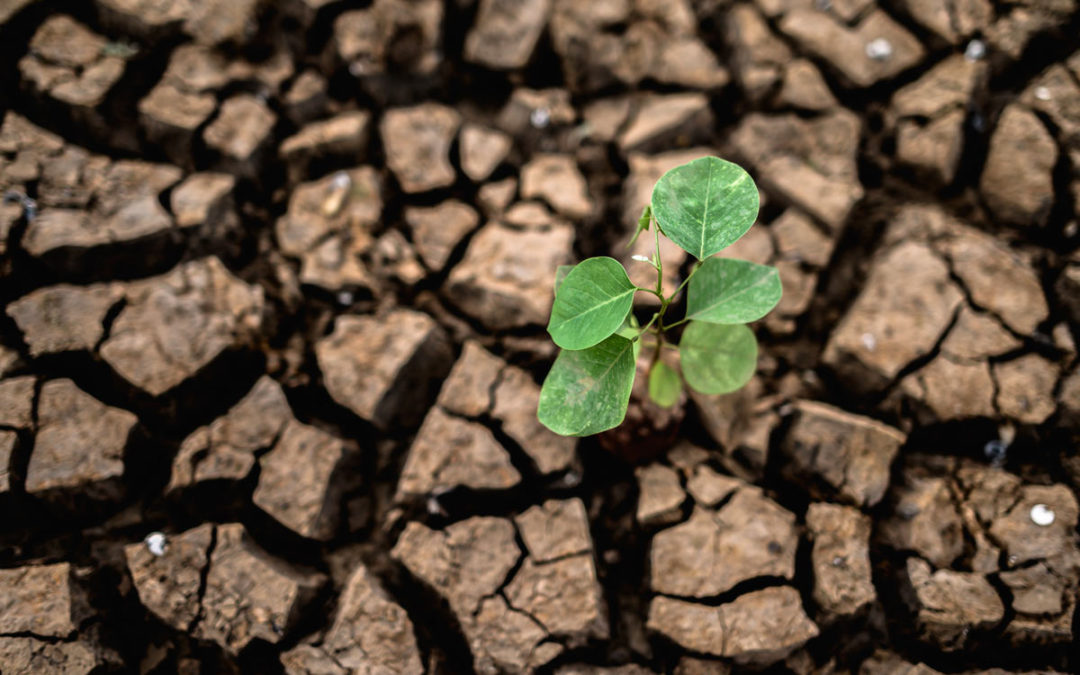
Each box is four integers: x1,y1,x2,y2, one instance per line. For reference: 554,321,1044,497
679,321,757,394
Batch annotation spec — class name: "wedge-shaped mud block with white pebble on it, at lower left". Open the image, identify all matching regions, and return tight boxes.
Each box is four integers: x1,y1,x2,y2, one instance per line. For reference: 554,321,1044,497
124,523,215,631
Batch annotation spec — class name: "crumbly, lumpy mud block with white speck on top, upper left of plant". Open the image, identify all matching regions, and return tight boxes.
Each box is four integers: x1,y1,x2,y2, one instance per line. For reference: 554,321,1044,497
274,166,382,293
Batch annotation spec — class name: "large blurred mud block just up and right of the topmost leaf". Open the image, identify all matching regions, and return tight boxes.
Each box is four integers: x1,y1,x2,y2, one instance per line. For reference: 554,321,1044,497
731,109,863,231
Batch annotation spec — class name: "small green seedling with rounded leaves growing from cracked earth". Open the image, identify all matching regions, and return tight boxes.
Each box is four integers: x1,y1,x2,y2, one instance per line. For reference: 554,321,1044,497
537,157,782,436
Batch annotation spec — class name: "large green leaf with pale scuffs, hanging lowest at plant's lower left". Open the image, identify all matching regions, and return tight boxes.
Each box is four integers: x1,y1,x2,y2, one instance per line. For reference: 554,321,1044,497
537,335,634,436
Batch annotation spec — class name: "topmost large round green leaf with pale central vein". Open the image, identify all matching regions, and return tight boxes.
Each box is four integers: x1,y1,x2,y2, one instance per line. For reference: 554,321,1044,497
652,157,759,260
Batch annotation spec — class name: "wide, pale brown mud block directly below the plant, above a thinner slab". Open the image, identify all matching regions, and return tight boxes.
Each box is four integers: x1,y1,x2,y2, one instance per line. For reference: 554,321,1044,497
649,487,798,597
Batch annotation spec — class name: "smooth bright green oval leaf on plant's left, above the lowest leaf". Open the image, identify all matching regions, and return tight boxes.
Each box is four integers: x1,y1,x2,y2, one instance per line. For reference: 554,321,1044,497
548,258,637,349
